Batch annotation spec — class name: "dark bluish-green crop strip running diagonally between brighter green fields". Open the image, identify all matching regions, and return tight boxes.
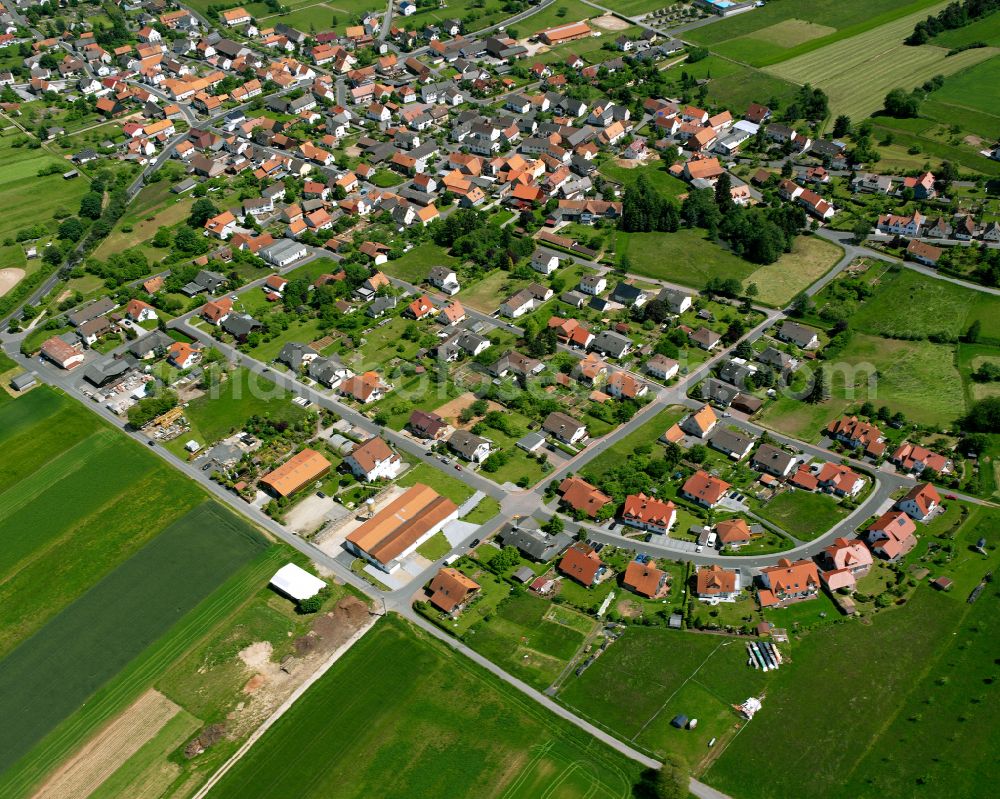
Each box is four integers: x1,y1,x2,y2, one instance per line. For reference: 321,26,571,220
0,502,267,780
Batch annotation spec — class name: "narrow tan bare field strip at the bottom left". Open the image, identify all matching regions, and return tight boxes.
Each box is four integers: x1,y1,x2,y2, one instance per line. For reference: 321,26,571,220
33,691,180,799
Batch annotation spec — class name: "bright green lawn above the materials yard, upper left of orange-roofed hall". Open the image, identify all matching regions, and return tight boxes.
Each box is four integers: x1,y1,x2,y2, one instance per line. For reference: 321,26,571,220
175,367,306,446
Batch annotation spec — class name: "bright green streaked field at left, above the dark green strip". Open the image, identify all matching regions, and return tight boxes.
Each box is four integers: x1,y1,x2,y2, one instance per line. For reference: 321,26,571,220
0,387,207,657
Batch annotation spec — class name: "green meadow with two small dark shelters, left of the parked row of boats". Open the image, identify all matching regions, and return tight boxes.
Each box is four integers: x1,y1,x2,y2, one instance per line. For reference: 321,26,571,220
558,627,770,772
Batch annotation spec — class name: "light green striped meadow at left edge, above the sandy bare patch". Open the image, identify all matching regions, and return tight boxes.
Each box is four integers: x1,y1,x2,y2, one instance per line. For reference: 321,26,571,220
0,132,89,245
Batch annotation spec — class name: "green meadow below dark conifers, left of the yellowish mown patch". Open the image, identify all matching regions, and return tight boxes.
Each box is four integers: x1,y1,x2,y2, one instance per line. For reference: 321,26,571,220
615,228,757,289
